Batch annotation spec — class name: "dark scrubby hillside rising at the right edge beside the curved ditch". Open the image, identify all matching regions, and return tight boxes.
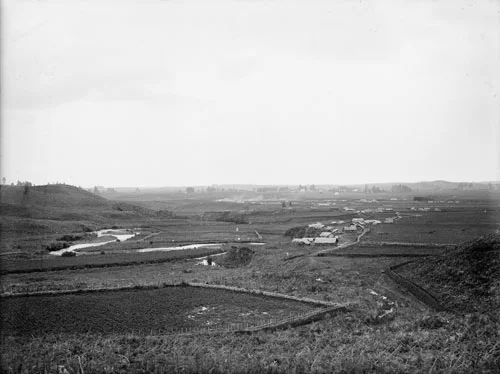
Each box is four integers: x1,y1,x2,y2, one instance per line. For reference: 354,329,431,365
398,233,500,315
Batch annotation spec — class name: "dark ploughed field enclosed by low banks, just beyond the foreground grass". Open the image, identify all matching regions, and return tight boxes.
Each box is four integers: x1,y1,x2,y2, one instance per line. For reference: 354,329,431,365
1,286,313,336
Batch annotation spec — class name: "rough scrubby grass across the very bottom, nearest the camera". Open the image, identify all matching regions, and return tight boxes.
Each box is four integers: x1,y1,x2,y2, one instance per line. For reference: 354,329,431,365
1,309,500,373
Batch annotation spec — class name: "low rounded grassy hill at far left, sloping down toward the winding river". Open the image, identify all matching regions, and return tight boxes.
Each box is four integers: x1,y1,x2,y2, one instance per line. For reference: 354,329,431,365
0,184,176,252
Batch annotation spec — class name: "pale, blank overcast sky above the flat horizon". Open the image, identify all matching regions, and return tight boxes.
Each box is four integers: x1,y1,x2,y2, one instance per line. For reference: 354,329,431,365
0,0,500,187
